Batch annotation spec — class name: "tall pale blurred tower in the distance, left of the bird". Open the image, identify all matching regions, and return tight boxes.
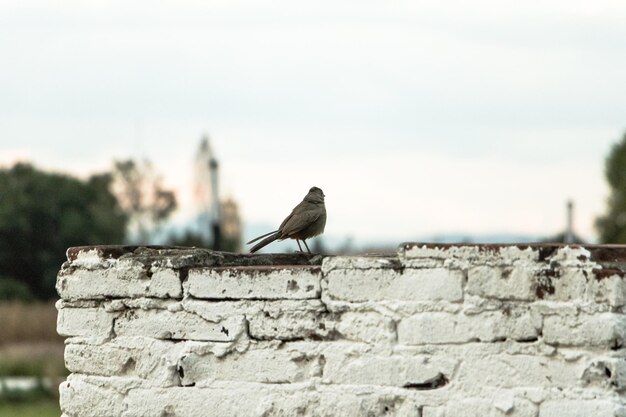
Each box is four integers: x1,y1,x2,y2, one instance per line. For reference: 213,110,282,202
193,135,221,249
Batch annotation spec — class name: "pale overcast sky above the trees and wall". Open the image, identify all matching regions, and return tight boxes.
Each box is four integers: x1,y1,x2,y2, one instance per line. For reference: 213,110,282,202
0,0,626,242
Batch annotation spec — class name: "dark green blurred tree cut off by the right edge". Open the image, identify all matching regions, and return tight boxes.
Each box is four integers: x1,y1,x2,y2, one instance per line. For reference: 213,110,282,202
596,133,626,243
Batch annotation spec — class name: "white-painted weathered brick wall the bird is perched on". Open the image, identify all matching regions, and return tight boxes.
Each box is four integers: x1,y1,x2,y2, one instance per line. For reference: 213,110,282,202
57,244,626,417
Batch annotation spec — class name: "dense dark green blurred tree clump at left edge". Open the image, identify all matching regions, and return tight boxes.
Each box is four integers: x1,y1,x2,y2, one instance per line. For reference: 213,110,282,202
0,164,126,298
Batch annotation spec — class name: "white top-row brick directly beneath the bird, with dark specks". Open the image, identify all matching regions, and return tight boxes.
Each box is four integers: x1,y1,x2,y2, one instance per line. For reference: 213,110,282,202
185,266,321,300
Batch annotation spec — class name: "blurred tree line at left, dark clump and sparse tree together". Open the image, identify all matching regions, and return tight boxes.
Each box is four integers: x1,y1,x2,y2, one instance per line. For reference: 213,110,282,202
0,160,176,300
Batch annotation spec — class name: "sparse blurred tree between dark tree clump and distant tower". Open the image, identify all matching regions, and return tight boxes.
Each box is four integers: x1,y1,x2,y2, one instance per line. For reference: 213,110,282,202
111,159,176,244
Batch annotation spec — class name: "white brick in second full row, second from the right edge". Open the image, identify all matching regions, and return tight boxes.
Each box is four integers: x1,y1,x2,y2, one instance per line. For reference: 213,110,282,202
398,312,539,345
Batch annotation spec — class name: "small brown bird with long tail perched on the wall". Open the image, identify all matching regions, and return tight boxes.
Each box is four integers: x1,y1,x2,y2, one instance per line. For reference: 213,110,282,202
246,187,326,254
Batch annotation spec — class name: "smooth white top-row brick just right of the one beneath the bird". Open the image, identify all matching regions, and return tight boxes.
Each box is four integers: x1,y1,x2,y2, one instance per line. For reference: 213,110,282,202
325,268,464,302
